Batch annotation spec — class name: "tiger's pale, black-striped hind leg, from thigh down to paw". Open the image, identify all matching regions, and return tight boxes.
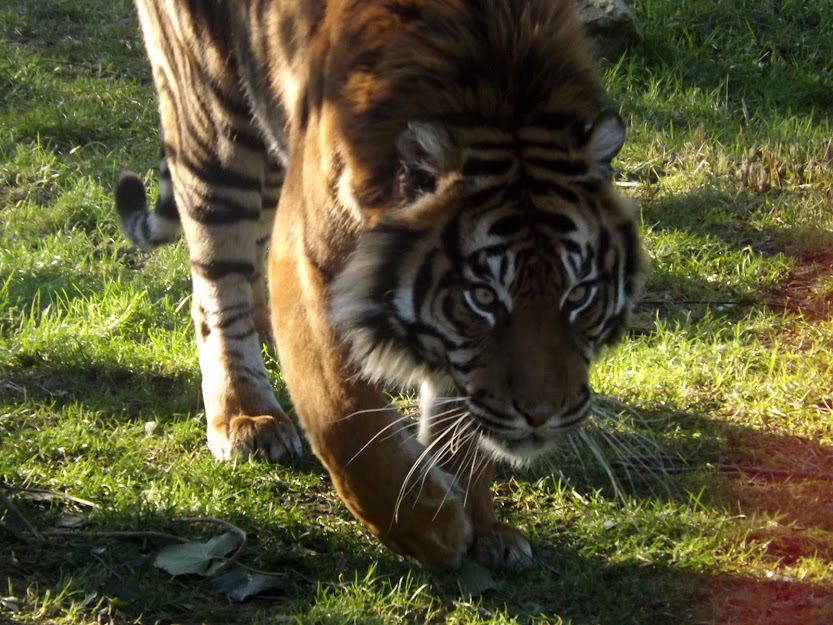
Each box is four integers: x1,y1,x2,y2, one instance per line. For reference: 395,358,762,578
137,2,301,461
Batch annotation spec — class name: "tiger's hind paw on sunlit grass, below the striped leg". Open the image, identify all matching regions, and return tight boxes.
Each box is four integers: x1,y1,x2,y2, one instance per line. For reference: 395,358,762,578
208,413,302,462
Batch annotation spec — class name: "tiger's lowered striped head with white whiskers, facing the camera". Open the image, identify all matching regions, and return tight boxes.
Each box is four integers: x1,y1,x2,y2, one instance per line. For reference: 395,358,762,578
330,112,643,462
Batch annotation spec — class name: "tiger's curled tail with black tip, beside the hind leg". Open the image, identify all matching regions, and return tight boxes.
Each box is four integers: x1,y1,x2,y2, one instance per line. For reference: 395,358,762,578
116,158,182,250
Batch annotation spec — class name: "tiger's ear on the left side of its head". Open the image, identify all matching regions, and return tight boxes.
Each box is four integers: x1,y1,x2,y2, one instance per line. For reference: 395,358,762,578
396,121,457,202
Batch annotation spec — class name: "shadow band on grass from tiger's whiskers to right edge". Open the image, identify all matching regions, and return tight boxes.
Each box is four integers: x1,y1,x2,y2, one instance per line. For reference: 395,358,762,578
544,397,833,520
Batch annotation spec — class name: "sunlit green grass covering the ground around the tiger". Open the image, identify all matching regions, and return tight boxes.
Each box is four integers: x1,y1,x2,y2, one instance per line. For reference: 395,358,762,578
0,0,833,625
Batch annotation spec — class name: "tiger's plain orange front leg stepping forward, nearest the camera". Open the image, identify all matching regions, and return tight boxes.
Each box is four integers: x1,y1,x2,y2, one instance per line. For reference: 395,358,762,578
269,225,471,568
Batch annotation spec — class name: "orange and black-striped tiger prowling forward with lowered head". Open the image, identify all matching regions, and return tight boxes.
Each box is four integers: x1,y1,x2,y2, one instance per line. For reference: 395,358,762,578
115,0,645,569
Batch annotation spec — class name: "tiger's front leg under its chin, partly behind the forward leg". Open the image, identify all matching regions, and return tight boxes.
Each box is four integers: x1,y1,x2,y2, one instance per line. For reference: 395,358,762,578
419,382,532,568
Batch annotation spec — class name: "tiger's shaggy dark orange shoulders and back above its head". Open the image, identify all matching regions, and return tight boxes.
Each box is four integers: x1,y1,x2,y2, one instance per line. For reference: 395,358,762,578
273,0,607,207
